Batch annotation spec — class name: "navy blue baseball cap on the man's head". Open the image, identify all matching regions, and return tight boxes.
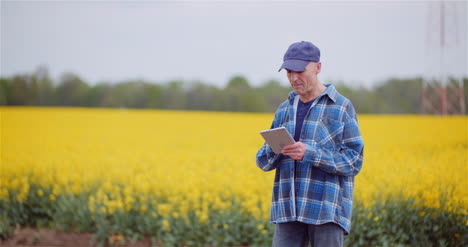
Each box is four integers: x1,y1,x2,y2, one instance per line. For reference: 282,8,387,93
278,41,320,72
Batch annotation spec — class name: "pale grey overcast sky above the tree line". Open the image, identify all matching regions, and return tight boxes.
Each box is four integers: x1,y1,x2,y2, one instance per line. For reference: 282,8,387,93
0,0,467,86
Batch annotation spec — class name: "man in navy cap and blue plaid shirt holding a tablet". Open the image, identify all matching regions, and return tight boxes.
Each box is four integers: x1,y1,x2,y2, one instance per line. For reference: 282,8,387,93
256,41,364,247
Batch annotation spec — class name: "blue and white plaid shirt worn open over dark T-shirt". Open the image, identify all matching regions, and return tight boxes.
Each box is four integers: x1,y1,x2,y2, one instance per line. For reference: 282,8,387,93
257,84,364,234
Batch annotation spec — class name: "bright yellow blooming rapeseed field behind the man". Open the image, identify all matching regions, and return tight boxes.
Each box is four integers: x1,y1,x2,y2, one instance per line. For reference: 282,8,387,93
0,107,468,225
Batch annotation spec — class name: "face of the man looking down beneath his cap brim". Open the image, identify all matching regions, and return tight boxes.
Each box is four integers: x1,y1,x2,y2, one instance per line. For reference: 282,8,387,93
286,62,322,97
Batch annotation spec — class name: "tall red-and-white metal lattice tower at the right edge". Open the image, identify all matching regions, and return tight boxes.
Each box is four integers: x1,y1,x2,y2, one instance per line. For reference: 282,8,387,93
421,1,468,115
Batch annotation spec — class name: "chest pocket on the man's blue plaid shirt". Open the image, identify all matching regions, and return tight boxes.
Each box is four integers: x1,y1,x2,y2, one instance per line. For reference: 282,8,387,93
314,118,344,150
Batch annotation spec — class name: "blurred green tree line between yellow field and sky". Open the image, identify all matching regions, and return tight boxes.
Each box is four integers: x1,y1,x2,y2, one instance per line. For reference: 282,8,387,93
0,68,468,114
